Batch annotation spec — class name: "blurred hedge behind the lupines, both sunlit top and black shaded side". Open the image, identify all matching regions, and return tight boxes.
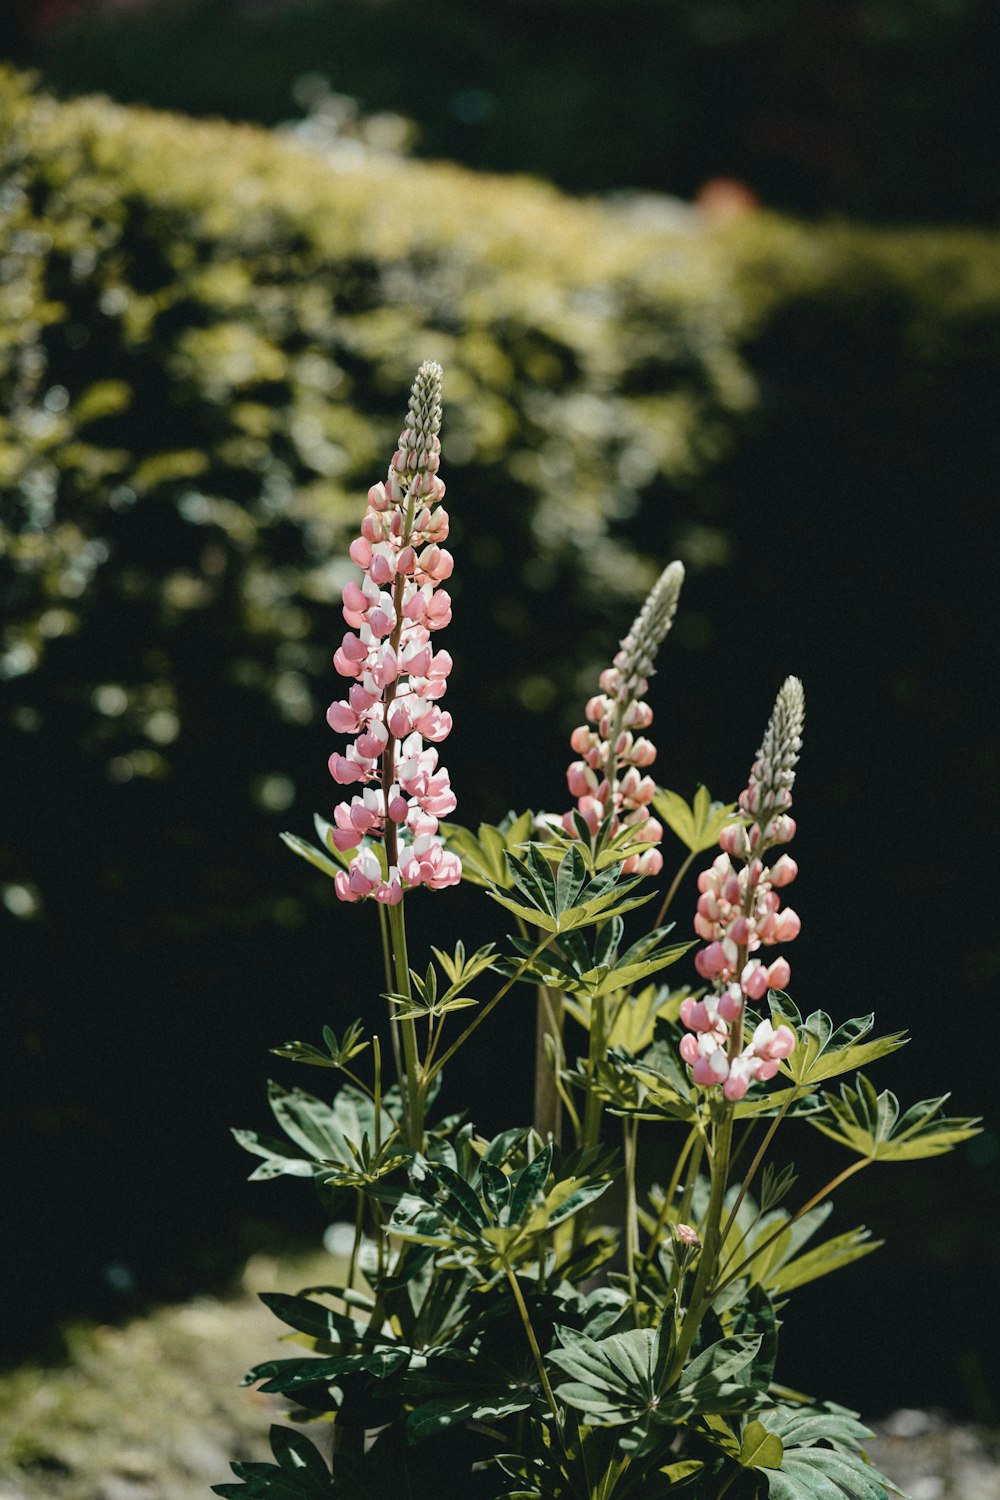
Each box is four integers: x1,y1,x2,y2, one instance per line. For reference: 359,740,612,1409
0,61,1000,1416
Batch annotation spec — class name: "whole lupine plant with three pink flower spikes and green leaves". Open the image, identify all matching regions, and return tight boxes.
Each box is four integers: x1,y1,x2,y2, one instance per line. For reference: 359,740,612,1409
214,363,976,1500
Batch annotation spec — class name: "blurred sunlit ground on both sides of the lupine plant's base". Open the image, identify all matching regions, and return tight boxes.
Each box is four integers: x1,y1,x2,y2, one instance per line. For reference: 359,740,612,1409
0,1257,1000,1500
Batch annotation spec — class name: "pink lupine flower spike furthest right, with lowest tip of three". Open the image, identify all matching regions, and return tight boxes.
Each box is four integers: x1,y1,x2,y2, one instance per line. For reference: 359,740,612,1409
681,677,805,1100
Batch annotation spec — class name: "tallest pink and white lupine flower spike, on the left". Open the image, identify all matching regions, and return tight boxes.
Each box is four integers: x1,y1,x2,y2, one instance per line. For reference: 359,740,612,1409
327,362,462,905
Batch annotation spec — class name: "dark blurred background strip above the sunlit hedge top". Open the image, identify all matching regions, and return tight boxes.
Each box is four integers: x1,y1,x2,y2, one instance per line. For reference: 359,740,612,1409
0,0,1000,224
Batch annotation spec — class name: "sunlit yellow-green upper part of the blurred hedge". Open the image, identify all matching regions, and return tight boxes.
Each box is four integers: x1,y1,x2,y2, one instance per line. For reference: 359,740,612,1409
0,72,1000,816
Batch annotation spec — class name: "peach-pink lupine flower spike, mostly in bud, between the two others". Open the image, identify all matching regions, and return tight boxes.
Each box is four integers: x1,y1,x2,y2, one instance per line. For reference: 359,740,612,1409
562,563,684,875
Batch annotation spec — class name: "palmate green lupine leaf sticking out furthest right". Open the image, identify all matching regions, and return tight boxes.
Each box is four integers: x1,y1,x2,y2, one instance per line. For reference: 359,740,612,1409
808,1073,982,1161
